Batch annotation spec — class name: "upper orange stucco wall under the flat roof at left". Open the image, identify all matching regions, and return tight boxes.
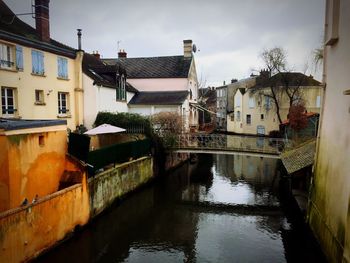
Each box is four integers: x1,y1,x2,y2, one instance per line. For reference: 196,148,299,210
0,131,67,211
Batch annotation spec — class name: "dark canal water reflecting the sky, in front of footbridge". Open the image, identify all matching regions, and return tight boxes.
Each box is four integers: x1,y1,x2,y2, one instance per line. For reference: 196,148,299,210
37,155,324,262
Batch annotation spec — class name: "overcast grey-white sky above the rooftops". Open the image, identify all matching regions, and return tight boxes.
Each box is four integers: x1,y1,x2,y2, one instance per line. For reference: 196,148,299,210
5,0,325,85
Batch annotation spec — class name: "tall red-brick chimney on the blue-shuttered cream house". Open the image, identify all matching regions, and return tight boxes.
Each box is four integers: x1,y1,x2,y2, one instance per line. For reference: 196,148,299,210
35,0,50,42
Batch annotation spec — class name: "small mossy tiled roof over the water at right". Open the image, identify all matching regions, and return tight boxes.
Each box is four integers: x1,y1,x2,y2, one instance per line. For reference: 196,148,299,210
281,140,316,174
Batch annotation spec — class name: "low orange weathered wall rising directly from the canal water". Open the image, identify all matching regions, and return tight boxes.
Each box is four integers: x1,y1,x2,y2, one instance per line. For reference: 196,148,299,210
0,182,90,262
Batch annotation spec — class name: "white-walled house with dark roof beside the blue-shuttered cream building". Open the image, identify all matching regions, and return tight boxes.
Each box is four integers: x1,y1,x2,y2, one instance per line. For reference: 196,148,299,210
83,52,138,129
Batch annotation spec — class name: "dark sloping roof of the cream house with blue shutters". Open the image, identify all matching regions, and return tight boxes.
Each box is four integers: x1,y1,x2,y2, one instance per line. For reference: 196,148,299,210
0,0,76,58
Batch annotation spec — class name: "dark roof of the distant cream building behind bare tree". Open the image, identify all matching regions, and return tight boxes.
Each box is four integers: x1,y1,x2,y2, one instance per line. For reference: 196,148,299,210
253,72,321,88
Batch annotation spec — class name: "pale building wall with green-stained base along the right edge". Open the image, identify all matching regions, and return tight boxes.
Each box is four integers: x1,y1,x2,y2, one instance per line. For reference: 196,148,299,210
308,0,350,262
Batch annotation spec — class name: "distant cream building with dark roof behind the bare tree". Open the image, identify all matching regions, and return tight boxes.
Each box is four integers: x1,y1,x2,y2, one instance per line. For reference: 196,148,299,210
227,71,322,135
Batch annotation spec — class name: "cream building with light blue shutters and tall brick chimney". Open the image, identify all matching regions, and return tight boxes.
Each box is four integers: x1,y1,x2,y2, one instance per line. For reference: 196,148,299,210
0,0,83,130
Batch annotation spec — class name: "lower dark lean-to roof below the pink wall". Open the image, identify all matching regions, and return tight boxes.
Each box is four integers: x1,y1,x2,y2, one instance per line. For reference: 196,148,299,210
129,91,188,105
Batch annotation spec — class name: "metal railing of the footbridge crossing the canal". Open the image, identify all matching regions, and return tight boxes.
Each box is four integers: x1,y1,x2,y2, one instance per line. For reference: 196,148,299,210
172,133,291,155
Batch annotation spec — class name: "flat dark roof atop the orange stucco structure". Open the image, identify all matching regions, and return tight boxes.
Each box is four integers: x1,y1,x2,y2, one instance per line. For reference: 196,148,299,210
0,118,67,131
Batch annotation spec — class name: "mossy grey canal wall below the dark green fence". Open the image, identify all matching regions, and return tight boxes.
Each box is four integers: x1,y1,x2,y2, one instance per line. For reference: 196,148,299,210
88,157,153,217
